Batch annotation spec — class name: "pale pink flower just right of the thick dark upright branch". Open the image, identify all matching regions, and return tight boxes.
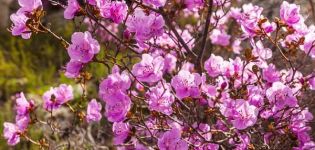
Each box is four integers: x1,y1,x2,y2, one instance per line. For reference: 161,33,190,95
205,54,224,77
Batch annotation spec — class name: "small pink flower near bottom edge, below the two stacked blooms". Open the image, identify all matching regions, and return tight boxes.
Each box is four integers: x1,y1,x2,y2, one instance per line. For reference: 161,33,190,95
112,122,130,145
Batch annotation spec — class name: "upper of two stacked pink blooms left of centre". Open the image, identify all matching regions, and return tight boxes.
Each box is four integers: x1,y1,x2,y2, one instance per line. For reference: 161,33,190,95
99,66,131,102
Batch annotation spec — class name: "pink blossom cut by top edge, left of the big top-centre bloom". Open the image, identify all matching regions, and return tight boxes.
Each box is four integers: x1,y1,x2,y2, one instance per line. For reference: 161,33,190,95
100,1,128,23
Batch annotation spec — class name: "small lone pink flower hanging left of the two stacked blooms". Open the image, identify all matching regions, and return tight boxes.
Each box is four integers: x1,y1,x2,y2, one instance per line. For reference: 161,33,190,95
86,99,102,123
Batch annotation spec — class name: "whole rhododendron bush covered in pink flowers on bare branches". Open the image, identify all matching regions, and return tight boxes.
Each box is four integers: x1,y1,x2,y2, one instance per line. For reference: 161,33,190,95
3,0,315,150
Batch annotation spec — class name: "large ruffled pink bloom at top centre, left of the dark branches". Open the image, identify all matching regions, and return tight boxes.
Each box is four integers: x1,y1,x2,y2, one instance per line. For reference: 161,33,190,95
126,8,165,42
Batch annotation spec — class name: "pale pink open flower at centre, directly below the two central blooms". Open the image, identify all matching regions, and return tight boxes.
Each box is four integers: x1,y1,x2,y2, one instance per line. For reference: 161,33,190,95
147,82,175,115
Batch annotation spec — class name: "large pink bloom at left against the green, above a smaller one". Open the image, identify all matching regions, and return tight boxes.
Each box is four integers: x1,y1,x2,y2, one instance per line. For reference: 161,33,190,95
68,31,100,63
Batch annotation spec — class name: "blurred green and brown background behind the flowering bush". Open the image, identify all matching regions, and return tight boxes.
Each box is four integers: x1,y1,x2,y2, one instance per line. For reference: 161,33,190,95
0,0,315,150
